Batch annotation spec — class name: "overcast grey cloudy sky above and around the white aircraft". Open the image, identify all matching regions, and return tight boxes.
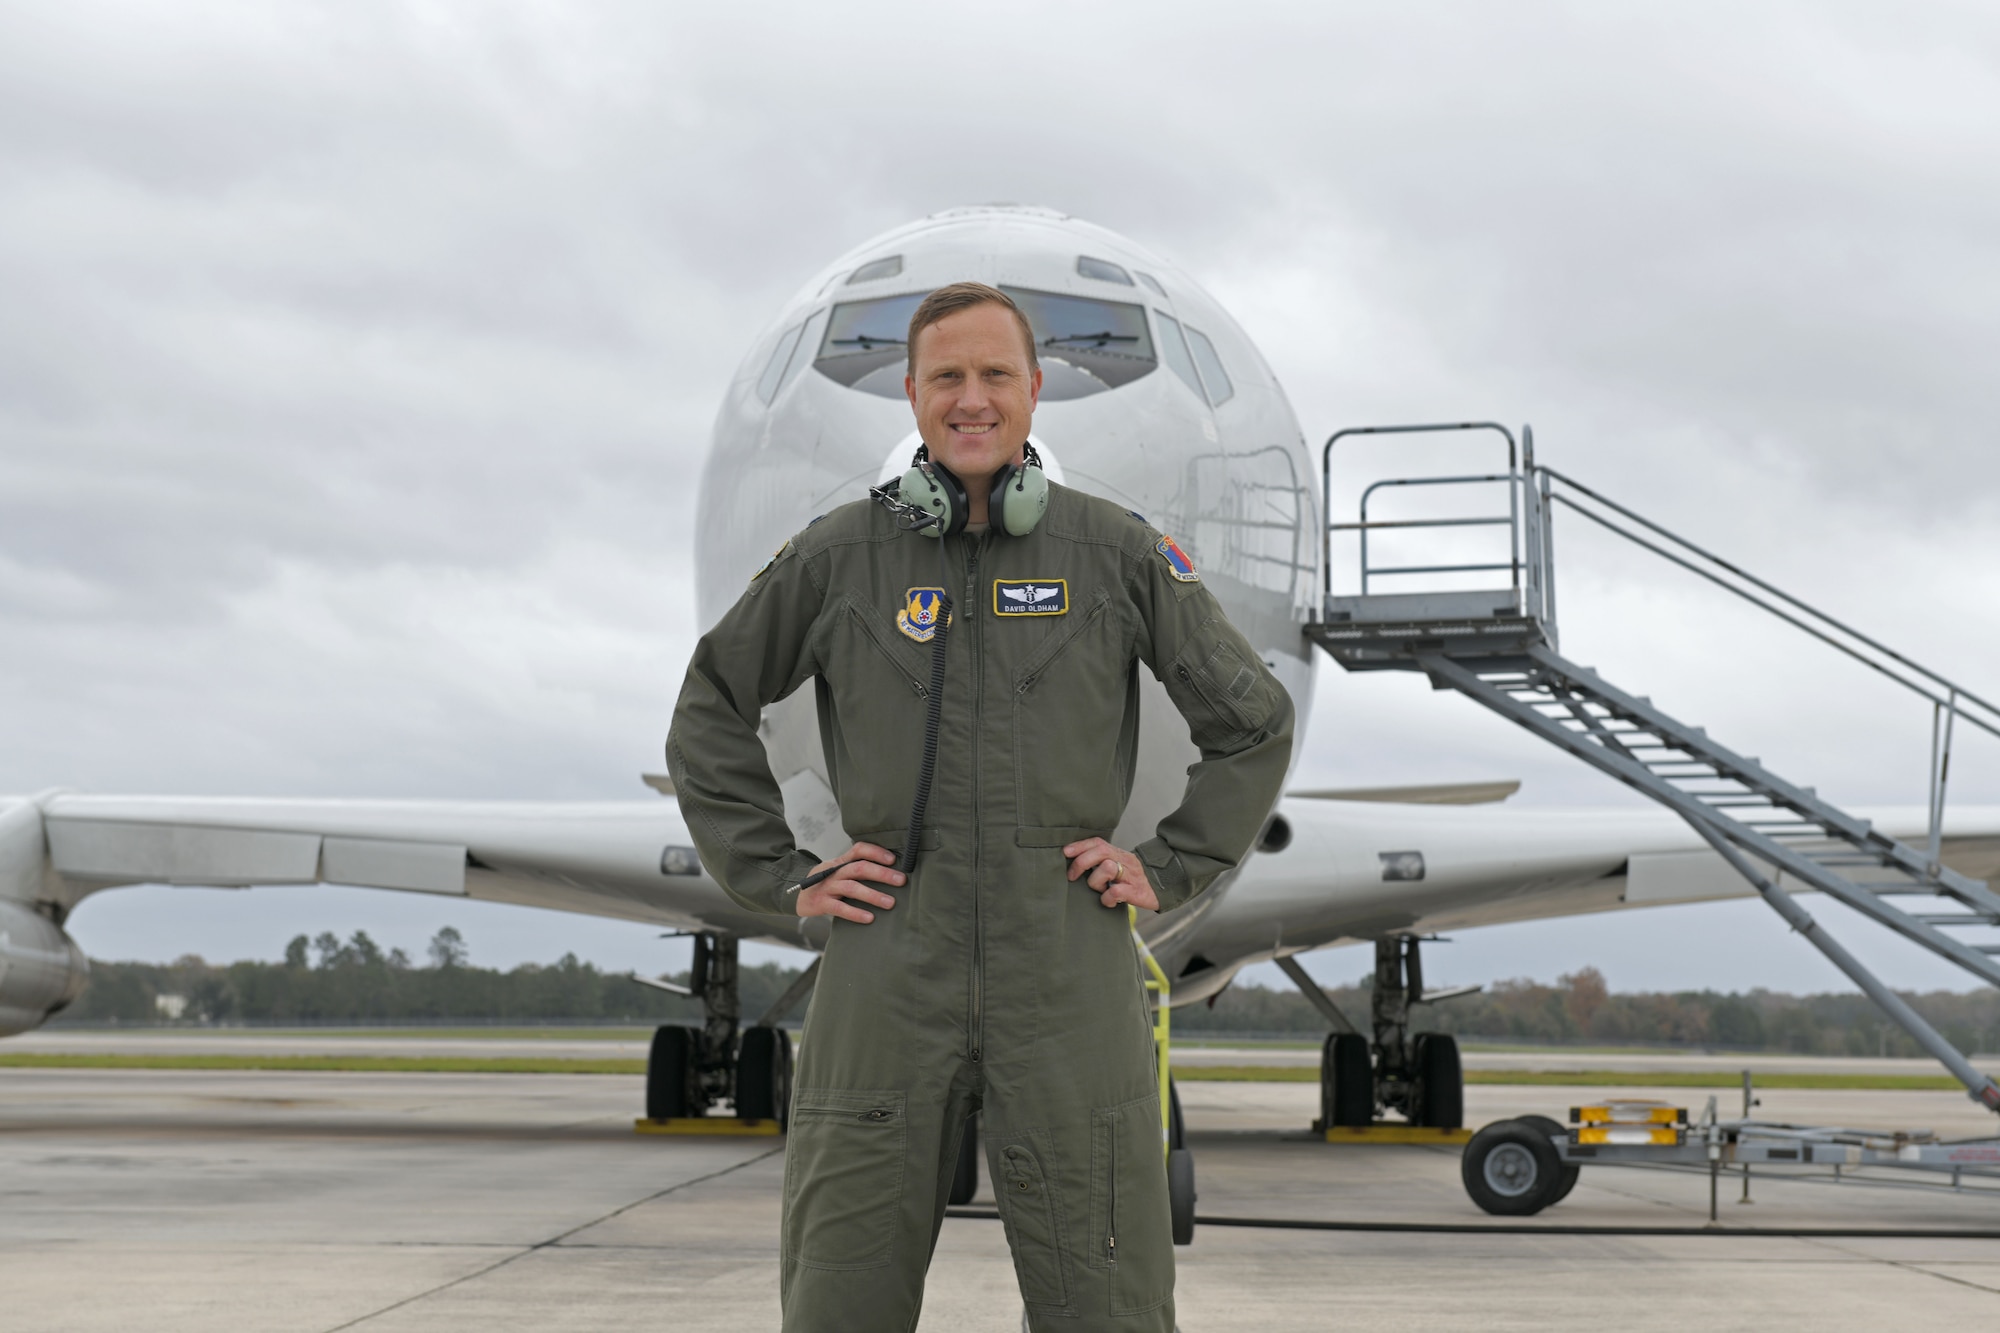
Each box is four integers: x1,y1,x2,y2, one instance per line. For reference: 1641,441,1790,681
0,0,2000,989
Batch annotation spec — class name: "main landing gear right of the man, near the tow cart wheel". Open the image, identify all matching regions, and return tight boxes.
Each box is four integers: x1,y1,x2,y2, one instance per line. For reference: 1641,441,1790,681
1278,935,1476,1131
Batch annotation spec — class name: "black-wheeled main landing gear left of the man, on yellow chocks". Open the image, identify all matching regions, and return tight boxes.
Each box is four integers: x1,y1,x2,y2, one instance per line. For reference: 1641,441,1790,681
634,931,820,1129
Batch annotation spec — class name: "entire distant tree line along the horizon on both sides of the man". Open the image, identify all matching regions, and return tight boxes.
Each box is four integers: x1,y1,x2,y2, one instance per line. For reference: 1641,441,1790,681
43,927,2000,1055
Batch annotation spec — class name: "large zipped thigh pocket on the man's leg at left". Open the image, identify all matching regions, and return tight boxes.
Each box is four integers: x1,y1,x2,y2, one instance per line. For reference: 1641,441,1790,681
784,1087,910,1269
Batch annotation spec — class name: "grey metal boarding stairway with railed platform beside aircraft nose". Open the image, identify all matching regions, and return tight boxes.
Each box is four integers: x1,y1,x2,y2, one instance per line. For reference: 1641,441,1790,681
1306,422,2000,1111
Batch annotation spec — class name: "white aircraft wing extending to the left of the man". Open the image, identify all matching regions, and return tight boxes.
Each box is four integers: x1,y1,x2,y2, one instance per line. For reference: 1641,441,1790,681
6,788,830,947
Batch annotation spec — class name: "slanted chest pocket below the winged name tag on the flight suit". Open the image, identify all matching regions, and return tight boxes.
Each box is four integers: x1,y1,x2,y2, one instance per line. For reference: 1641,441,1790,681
998,592,1138,829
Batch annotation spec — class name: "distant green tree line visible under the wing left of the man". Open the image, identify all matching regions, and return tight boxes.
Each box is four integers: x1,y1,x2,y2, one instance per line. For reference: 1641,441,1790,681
56,927,798,1027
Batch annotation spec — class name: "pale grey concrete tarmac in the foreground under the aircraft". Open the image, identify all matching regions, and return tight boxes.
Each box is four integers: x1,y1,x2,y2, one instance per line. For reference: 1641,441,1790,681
0,1045,2000,1333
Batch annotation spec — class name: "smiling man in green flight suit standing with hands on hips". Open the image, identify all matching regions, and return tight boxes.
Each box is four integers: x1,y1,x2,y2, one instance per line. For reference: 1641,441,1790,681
666,282,1292,1333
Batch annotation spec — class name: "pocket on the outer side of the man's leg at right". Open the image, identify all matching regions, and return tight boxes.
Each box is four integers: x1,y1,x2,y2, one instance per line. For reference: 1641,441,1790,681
1090,1095,1174,1315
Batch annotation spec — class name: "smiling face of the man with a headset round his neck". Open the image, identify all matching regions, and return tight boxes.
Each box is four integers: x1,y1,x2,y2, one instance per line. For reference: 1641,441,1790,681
902,302,1042,488
